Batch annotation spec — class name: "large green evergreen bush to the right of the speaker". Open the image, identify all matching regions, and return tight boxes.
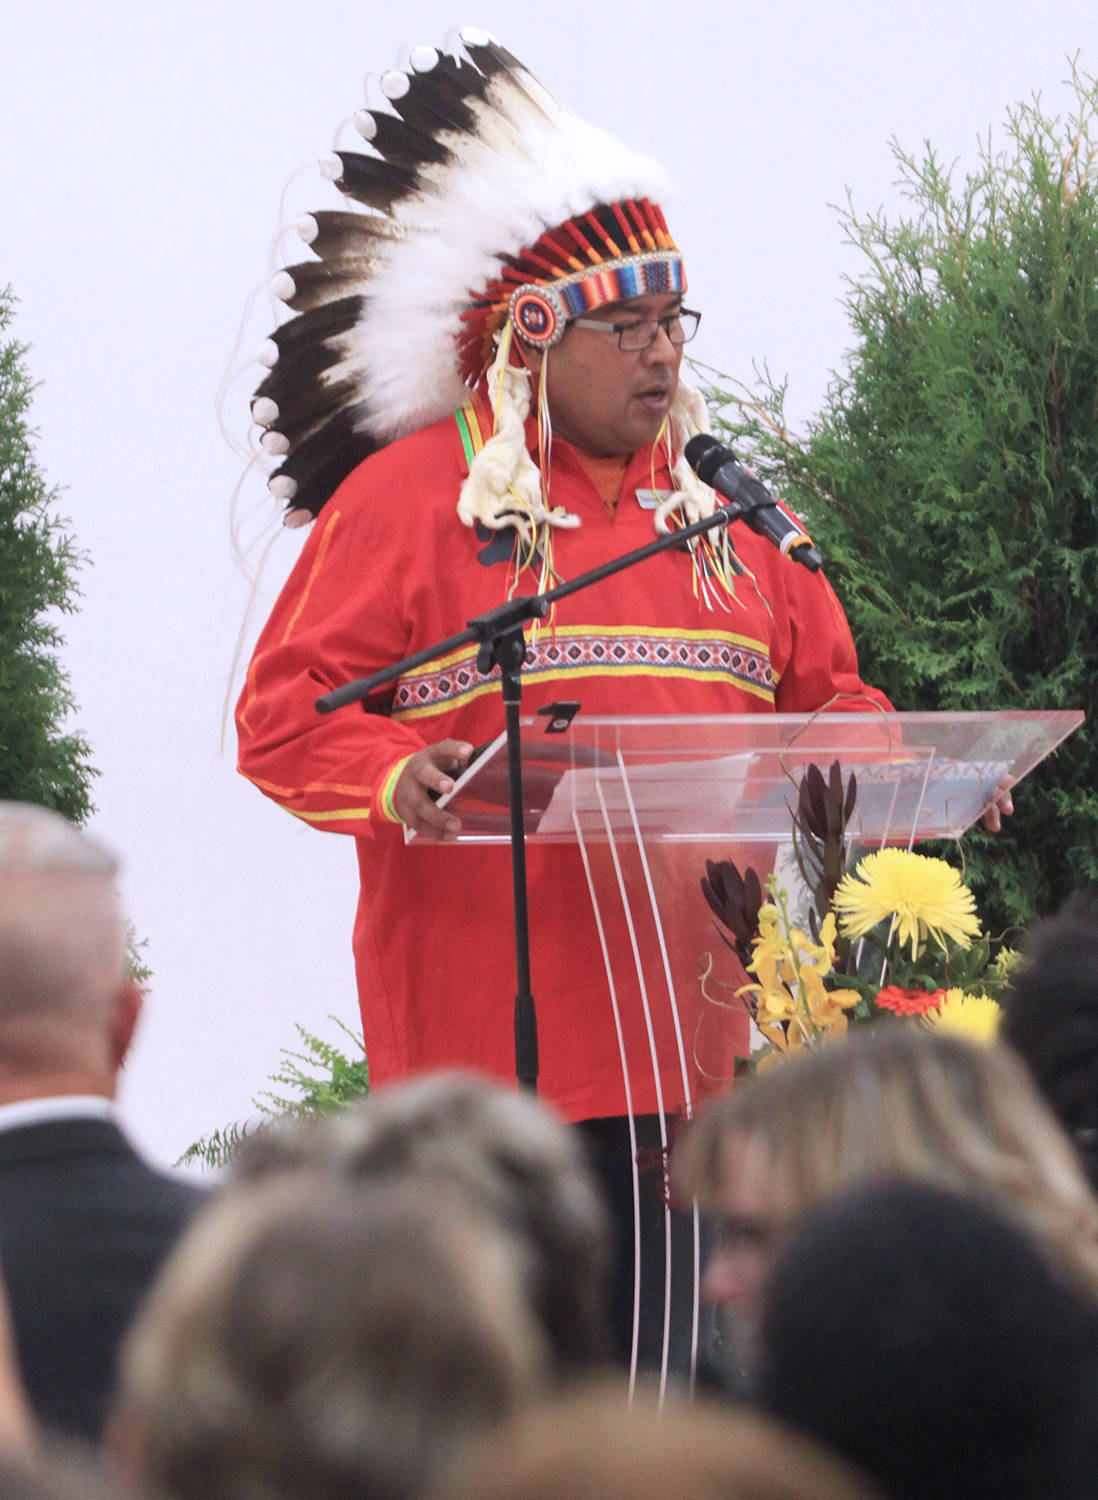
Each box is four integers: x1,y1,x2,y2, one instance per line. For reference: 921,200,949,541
708,65,1098,933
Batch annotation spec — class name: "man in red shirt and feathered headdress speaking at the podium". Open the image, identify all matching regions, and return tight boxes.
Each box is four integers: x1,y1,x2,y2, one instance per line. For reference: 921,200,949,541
237,32,888,1364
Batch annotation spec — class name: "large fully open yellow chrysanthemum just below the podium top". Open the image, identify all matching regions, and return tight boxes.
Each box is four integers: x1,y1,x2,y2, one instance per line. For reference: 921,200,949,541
833,849,980,957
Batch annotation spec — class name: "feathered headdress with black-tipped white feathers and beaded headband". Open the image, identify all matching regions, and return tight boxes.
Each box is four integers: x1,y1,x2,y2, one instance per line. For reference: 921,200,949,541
252,29,726,582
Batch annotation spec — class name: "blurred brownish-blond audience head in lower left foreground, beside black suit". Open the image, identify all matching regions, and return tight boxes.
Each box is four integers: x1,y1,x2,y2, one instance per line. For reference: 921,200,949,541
110,1175,546,1500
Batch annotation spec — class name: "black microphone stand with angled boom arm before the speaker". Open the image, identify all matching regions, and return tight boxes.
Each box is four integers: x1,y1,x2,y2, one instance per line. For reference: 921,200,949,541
317,500,756,1092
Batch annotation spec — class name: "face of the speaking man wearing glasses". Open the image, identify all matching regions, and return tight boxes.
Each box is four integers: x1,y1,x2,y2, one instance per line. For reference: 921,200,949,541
546,293,683,458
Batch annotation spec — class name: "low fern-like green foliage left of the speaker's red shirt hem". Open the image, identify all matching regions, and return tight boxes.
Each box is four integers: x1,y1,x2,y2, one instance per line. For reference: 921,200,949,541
177,1016,371,1167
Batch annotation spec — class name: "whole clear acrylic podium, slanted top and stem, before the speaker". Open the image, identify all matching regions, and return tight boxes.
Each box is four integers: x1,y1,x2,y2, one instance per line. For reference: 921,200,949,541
410,705,1083,1374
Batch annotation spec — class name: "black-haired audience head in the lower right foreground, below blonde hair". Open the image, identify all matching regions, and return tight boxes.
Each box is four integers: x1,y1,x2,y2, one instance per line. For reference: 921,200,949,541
758,1181,1098,1500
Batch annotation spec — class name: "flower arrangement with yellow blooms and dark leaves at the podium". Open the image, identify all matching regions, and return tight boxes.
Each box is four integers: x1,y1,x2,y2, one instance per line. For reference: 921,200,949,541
702,761,1017,1067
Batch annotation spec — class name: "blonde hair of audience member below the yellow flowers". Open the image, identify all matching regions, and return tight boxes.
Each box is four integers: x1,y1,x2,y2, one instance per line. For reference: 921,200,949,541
674,1023,1098,1299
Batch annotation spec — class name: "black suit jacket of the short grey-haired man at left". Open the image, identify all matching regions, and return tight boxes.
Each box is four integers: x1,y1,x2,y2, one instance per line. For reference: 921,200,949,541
0,1118,206,1442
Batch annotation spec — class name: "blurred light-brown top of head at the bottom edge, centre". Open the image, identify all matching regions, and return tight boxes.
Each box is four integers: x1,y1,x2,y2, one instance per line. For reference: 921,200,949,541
432,1386,878,1500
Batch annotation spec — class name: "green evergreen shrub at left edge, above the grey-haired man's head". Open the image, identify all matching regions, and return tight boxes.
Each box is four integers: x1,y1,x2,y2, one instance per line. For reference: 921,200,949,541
0,288,95,824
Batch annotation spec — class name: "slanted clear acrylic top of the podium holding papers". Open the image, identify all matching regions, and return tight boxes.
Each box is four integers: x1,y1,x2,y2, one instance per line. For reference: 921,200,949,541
432,710,1083,845
